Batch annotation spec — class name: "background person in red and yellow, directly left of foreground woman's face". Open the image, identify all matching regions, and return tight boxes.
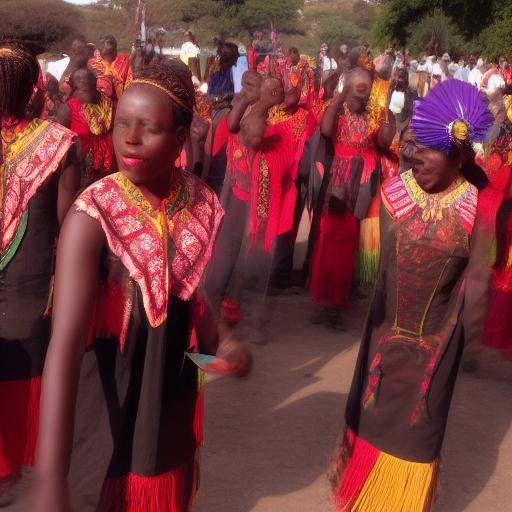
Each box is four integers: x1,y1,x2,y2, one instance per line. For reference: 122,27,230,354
57,68,114,187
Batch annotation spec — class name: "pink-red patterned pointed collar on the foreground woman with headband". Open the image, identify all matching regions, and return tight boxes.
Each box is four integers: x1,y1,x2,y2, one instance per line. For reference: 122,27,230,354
75,172,223,327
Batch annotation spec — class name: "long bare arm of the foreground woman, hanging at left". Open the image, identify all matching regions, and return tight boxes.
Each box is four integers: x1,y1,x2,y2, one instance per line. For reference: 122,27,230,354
32,211,105,512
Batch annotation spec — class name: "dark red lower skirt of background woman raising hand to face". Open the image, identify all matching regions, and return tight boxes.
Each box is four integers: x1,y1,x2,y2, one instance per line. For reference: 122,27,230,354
309,211,359,307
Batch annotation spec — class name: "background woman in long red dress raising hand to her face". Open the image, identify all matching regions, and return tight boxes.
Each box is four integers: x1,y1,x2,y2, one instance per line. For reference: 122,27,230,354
310,68,395,328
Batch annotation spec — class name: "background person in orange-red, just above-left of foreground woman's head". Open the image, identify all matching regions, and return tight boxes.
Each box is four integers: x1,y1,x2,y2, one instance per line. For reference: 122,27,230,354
87,35,132,100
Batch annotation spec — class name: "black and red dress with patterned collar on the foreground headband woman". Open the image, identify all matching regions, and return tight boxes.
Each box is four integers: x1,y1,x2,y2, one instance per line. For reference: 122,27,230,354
69,171,222,512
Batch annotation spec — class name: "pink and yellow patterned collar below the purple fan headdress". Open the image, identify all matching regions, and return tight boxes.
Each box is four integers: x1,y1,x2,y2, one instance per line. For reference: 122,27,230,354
383,170,478,233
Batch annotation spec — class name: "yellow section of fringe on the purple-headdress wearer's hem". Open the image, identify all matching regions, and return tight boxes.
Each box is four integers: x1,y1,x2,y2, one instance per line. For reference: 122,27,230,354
350,453,439,512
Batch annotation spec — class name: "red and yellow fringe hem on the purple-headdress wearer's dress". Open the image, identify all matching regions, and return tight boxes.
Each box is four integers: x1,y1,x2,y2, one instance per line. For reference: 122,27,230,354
334,430,439,512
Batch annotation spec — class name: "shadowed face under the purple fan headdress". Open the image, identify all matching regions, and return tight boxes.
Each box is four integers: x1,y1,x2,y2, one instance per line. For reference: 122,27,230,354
411,147,457,194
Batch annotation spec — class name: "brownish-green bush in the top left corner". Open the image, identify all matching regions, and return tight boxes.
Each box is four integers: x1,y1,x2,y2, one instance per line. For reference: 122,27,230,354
0,0,84,52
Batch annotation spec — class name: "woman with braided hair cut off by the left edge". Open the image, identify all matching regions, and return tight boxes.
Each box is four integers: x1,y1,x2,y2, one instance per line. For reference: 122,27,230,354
0,42,79,496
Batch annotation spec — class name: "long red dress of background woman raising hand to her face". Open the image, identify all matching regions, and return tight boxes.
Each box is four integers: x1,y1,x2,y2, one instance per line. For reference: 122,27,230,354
310,105,378,306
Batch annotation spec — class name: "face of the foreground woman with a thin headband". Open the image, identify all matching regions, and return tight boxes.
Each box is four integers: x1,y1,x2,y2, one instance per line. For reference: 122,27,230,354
113,84,186,185
